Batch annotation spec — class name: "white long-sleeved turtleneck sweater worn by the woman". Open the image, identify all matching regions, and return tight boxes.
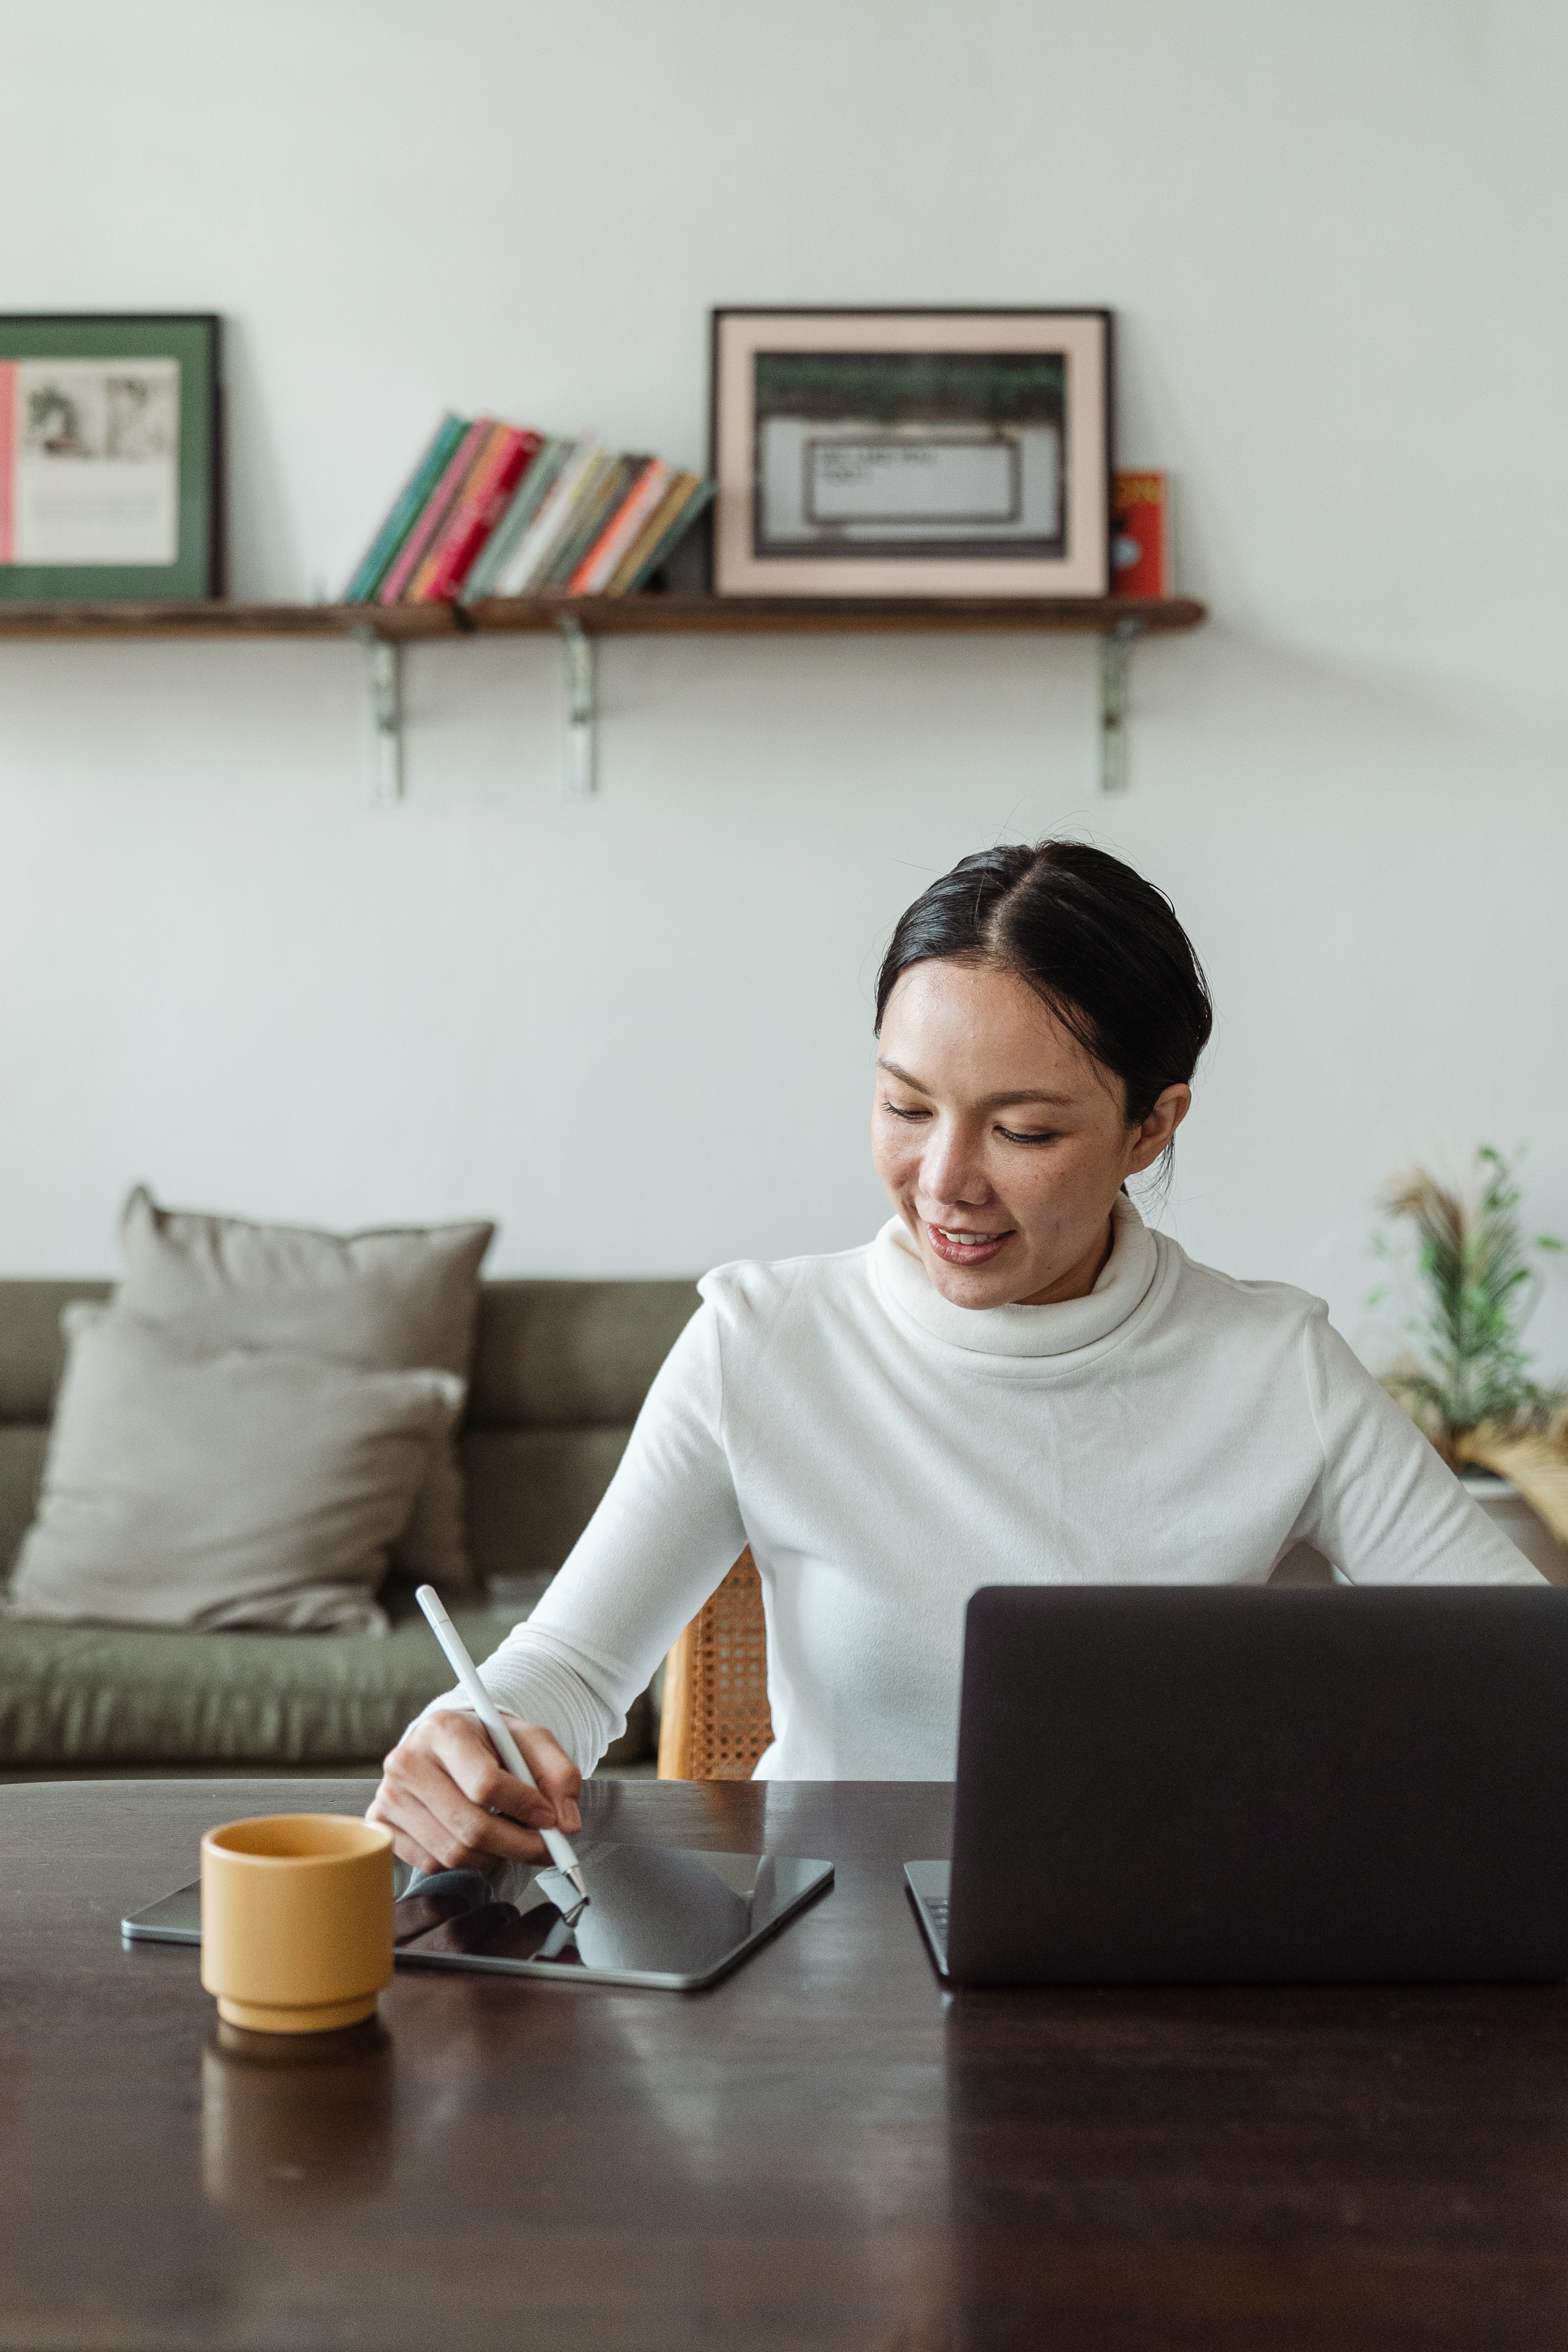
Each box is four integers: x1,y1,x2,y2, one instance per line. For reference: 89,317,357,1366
423,1199,1540,1780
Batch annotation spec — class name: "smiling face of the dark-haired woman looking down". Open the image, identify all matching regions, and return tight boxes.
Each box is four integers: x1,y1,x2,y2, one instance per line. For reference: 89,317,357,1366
872,960,1192,1308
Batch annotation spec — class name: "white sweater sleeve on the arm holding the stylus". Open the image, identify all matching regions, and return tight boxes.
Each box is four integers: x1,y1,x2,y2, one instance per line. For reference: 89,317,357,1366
425,1306,748,1773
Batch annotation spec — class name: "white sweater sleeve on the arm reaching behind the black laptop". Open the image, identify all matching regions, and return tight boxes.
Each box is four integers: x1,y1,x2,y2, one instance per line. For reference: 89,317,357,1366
1298,1306,1542,1585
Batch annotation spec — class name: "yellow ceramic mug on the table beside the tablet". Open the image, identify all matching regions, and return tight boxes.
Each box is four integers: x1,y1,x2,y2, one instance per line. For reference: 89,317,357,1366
202,1813,393,2034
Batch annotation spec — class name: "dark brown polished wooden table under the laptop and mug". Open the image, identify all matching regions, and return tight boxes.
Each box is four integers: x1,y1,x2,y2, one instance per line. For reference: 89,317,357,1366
0,1780,1568,2352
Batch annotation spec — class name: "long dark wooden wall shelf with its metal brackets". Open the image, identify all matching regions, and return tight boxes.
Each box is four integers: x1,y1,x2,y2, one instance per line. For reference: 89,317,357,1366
0,593,1206,802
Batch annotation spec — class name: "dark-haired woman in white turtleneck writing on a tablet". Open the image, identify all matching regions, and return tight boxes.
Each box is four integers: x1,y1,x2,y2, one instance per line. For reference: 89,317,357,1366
369,842,1537,1867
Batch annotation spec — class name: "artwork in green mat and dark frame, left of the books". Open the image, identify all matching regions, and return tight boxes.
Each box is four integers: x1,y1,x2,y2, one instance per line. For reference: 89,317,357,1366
0,313,221,604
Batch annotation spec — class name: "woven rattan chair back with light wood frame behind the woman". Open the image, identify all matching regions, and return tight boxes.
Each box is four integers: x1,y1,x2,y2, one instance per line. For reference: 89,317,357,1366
658,1550,773,1780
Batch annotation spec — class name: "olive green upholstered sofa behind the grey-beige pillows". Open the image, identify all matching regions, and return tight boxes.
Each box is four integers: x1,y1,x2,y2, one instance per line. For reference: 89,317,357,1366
0,1282,698,1780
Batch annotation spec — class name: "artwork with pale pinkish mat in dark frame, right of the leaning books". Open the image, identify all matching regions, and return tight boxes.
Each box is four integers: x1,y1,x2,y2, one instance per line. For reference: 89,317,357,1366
712,311,1112,597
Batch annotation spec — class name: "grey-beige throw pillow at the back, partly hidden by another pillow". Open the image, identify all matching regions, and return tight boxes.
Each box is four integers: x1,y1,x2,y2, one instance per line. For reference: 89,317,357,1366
118,1185,496,1592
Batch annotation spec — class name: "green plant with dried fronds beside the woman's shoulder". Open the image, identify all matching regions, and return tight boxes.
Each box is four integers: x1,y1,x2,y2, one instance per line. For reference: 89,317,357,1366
1371,1146,1568,1543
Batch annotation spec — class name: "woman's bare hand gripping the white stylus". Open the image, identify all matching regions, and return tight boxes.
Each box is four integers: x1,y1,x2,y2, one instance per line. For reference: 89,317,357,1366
364,1708,583,1870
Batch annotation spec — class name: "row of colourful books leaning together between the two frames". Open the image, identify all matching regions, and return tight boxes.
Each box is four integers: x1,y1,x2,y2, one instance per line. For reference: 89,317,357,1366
343,416,712,604
